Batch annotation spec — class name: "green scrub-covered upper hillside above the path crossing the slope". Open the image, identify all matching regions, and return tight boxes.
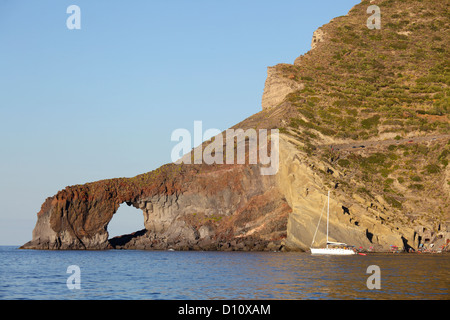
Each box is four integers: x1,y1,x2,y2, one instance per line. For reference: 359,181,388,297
279,0,450,140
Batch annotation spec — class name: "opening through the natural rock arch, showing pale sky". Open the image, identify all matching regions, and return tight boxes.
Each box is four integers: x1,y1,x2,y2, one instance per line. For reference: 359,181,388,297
107,203,145,239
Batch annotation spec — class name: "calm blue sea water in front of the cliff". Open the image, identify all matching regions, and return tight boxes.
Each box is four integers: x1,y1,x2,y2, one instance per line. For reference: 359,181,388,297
0,247,450,300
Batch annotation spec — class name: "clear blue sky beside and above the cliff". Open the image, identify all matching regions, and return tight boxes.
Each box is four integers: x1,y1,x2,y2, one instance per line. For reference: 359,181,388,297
0,0,358,245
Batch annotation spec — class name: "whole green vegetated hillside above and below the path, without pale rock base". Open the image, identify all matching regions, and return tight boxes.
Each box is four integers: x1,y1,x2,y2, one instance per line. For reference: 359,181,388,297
249,0,450,234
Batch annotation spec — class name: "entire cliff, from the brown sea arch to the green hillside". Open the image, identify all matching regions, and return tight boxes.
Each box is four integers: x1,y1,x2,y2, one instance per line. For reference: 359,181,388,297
23,0,450,251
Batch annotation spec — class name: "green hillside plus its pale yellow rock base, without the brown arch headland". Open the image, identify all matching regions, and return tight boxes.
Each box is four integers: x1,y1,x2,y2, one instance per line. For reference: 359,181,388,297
259,0,450,250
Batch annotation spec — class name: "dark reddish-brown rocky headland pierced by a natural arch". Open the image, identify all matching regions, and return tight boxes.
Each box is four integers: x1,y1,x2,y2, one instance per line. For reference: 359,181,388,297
23,165,290,250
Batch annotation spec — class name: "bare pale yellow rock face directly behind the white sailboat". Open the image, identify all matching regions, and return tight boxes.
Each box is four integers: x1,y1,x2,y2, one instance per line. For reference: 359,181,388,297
277,139,415,251
